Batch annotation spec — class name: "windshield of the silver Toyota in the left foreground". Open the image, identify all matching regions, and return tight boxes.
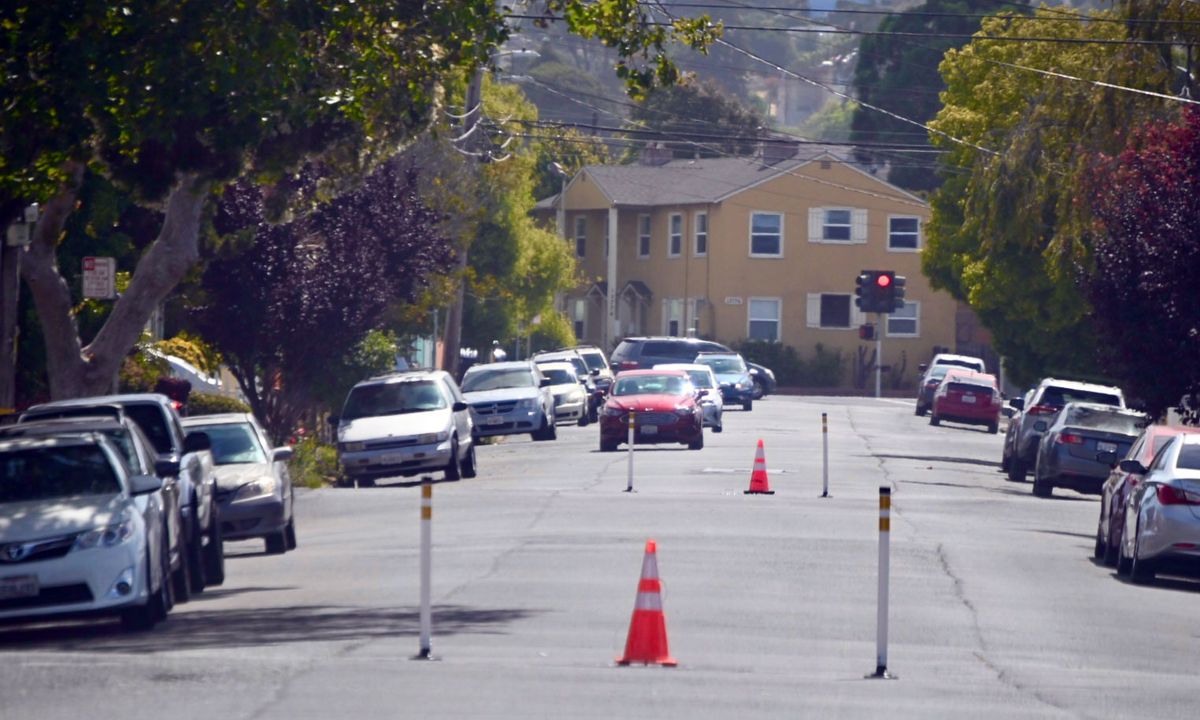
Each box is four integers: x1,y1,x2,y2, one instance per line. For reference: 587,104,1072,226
0,445,121,503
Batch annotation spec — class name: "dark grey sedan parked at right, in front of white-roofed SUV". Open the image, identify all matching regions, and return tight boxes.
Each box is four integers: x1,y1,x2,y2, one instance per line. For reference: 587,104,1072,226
1033,402,1147,498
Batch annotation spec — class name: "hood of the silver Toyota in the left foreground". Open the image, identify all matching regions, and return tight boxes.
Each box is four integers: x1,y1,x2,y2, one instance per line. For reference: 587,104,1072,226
0,494,130,542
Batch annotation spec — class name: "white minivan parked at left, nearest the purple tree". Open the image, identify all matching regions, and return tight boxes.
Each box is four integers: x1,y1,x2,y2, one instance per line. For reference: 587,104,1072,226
329,370,478,487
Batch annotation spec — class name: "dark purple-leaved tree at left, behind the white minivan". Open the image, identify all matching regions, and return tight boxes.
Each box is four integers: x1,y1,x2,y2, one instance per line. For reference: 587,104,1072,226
191,158,454,439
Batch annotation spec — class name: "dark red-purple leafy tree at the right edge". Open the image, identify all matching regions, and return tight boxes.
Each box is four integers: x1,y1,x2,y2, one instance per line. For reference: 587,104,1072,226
1085,108,1200,418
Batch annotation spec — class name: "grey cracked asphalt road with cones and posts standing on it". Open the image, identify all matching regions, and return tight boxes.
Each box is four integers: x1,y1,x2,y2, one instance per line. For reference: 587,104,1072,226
0,396,1200,720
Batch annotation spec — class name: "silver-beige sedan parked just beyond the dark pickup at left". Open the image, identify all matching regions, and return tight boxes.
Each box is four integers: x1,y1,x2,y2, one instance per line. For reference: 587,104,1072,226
184,413,296,554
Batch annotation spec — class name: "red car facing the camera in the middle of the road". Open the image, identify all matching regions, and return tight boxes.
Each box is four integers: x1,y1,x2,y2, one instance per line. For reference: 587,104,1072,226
600,370,704,452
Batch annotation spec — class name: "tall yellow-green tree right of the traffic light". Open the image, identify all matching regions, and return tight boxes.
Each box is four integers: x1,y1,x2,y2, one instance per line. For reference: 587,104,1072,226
922,8,1166,384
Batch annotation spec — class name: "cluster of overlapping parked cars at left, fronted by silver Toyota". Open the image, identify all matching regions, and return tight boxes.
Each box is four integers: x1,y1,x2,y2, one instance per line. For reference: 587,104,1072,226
0,394,296,629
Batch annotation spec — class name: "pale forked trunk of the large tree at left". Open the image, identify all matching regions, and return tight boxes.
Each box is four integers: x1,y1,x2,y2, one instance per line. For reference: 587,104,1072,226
22,168,209,400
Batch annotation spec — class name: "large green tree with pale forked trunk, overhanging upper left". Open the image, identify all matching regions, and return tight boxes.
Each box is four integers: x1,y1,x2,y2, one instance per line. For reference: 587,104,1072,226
0,0,719,397
